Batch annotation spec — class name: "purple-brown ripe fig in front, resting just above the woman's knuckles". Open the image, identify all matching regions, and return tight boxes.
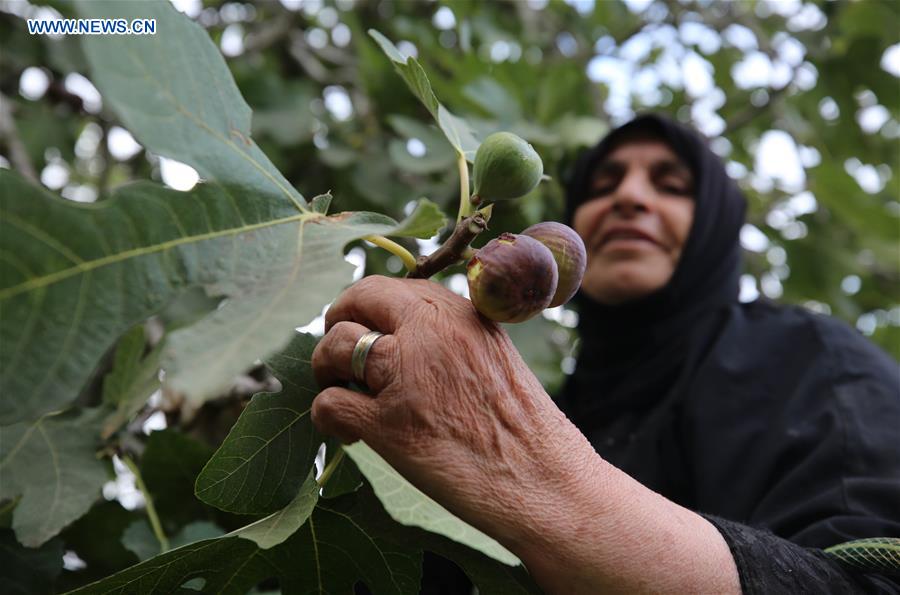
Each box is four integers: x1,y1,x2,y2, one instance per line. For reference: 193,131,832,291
466,233,558,322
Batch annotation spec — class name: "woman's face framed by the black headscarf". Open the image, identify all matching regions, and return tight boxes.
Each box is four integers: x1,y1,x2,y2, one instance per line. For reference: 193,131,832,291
574,140,694,304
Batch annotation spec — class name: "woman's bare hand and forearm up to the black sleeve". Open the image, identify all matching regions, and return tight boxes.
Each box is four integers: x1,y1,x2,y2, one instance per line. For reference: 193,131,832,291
312,277,740,594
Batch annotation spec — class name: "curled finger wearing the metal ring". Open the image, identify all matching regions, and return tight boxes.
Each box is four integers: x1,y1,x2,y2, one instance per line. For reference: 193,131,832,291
312,320,399,393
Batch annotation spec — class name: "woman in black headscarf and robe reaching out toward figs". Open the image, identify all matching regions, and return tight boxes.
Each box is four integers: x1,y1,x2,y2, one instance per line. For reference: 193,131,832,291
312,116,900,593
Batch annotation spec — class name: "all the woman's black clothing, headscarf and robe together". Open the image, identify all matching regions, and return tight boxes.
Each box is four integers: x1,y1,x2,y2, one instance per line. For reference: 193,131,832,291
557,116,900,593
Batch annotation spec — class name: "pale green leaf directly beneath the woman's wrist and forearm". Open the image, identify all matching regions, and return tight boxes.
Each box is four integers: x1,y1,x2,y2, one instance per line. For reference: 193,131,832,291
344,441,519,566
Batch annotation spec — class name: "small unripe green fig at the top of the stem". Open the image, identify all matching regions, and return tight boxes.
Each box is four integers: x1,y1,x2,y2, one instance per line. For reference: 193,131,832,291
472,132,544,202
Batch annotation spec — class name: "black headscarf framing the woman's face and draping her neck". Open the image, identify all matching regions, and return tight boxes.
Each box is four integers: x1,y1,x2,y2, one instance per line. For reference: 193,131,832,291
562,115,746,421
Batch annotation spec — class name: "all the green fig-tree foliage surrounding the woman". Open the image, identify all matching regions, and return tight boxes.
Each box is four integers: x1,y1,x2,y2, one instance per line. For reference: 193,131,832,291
0,0,900,593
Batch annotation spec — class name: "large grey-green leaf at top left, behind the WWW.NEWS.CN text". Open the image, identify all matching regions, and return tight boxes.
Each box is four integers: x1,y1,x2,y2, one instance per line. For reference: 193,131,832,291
77,0,306,209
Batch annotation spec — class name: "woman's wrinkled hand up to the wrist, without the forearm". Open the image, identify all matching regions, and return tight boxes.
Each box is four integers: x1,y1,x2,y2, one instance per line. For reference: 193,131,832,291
312,277,593,546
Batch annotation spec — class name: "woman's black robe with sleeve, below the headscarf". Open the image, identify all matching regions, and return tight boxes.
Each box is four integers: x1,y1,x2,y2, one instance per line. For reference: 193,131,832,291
558,301,900,593
